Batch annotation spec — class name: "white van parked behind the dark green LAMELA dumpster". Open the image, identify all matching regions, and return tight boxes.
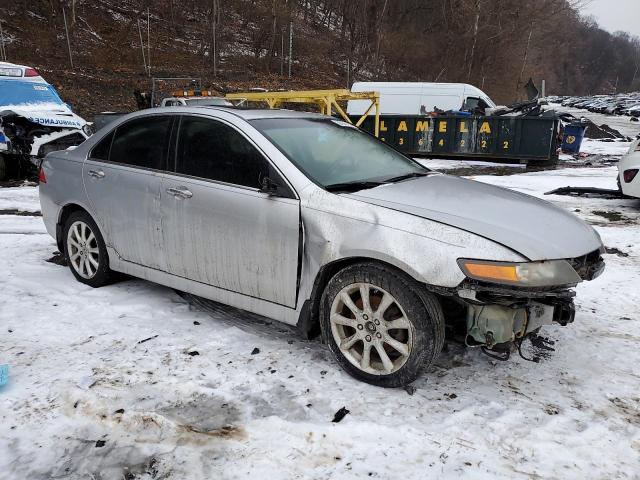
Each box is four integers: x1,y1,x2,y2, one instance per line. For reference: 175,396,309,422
347,82,496,115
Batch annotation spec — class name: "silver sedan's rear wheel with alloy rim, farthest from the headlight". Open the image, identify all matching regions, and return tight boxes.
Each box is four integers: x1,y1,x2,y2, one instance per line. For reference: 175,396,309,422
62,211,113,288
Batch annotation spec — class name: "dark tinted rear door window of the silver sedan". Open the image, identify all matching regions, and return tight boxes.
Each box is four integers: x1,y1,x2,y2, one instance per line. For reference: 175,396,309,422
109,116,172,170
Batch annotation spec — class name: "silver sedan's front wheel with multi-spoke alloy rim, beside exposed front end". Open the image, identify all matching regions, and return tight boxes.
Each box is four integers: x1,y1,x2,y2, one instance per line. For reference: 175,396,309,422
320,262,445,387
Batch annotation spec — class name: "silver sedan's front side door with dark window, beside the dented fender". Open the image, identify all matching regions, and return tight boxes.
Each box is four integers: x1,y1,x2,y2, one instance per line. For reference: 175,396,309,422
162,116,300,307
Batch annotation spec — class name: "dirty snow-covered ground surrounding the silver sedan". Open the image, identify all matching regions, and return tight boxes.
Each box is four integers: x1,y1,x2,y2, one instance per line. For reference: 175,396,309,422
0,142,640,480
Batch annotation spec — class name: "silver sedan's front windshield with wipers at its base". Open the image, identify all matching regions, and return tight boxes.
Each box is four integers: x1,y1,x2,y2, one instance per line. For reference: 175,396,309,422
251,118,430,191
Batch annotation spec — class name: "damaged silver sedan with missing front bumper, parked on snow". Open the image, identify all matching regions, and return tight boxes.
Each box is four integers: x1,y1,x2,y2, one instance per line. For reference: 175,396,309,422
40,107,604,387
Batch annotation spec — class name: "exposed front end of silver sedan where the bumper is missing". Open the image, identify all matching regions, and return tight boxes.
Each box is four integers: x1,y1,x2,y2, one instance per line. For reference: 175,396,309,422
441,250,604,360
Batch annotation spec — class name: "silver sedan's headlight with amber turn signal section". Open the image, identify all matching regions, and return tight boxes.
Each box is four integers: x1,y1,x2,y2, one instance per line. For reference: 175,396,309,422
458,258,582,287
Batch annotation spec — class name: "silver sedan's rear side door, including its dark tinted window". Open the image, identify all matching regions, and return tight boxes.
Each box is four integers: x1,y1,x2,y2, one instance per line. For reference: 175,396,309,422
83,115,177,270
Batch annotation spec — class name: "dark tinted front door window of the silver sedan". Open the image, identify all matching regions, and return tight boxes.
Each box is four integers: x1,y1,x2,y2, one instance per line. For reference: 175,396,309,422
176,117,269,188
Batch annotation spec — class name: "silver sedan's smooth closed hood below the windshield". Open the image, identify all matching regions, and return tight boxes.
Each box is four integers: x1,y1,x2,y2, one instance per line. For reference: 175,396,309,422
343,174,602,261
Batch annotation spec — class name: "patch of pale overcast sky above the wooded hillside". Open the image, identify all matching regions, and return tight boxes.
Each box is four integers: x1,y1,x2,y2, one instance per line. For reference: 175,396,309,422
582,0,640,37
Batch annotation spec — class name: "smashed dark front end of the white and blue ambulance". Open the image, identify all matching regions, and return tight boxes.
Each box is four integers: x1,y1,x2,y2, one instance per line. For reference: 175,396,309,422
0,110,91,180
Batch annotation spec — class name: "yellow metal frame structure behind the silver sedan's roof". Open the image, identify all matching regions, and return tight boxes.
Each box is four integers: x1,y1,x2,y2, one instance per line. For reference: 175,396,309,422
225,89,380,137
